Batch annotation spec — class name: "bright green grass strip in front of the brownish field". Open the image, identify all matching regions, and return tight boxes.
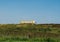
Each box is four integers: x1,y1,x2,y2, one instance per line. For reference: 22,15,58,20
0,37,60,42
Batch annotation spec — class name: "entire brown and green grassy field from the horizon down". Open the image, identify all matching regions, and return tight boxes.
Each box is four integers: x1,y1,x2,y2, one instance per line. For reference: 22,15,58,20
0,24,60,42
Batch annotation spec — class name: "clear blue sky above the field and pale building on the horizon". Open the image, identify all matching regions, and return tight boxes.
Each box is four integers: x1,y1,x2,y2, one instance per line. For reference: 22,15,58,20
0,0,60,24
